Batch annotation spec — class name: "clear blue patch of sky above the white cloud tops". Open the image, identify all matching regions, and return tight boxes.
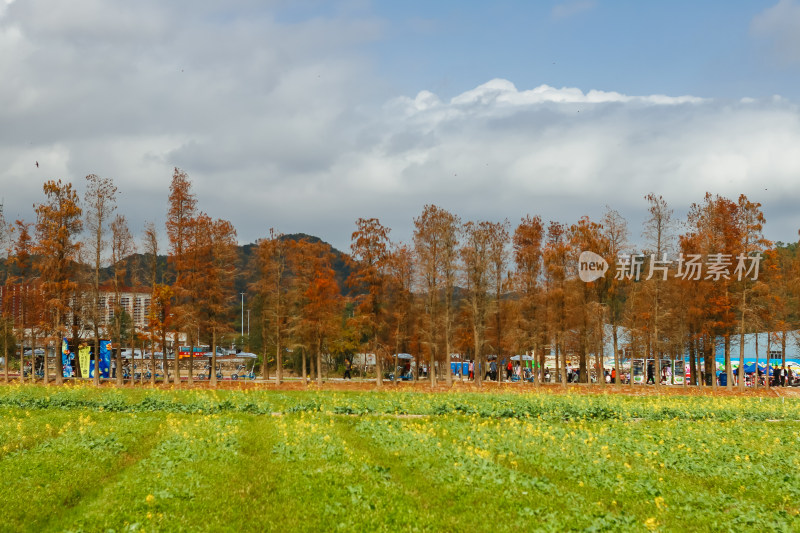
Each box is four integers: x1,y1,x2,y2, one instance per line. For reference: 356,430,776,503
371,0,800,99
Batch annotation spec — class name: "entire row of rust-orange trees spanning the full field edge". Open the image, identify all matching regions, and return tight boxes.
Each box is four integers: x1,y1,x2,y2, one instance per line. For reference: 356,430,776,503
2,169,800,385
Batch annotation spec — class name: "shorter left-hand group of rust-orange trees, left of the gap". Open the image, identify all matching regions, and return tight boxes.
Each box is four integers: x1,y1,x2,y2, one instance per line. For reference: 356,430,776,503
0,169,238,384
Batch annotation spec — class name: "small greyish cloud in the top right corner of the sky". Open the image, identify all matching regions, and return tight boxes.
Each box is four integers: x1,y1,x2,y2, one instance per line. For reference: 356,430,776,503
750,0,800,65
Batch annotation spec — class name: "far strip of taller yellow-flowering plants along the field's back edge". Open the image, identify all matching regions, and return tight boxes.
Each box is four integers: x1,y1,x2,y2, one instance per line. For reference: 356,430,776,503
0,385,800,421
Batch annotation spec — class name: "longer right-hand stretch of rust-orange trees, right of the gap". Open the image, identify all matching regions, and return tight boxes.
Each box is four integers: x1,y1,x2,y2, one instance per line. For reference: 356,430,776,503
253,194,800,386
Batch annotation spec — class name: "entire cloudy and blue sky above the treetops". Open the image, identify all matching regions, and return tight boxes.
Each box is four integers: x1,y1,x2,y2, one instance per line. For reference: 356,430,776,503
0,0,800,254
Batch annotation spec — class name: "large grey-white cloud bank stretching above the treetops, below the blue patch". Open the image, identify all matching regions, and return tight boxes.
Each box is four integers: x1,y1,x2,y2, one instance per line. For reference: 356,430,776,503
0,0,800,254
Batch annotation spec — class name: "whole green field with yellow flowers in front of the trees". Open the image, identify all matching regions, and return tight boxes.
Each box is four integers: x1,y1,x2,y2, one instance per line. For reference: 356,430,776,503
0,386,800,532
